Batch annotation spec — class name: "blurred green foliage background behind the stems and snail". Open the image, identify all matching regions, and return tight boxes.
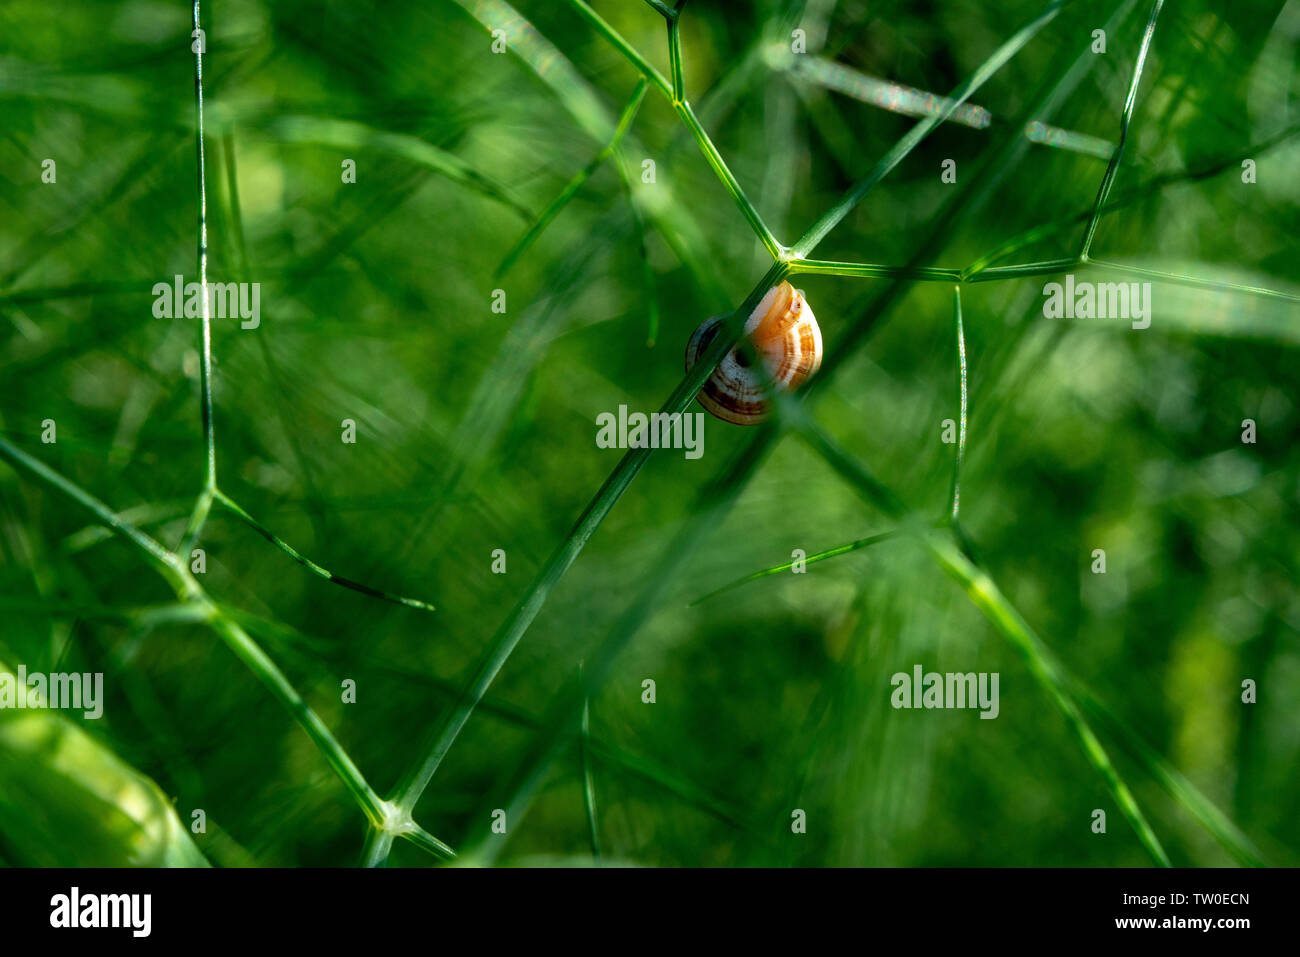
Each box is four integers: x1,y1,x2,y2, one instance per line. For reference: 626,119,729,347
0,0,1300,866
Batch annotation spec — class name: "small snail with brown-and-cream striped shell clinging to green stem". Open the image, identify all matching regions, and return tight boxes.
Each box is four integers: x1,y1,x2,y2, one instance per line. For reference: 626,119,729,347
686,282,822,425
